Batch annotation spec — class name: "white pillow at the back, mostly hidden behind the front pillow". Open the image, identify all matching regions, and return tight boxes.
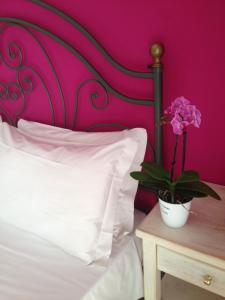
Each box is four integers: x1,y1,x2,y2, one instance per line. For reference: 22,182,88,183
18,119,147,239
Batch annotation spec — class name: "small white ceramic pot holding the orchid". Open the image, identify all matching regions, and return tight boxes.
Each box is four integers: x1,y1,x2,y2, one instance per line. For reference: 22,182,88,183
159,198,191,228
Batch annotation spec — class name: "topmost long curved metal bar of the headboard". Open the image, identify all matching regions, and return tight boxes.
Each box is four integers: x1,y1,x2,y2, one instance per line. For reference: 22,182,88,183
31,0,154,78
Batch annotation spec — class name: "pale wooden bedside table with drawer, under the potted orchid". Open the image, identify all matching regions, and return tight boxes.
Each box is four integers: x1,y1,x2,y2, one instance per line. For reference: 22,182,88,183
136,184,225,300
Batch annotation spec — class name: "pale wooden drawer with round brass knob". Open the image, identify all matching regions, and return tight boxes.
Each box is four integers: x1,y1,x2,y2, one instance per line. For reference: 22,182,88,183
157,246,225,296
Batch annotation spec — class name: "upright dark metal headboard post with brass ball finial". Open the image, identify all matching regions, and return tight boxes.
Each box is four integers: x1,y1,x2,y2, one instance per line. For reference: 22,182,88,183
150,43,164,164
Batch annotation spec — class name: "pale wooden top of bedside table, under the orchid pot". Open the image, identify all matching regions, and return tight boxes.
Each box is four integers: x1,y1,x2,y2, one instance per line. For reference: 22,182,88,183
136,183,225,269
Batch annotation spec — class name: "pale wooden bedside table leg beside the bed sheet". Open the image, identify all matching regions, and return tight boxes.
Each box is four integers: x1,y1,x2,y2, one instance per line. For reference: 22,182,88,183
143,240,161,300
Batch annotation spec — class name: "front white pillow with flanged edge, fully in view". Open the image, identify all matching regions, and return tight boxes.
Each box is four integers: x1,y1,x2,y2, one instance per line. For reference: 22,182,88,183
0,122,137,263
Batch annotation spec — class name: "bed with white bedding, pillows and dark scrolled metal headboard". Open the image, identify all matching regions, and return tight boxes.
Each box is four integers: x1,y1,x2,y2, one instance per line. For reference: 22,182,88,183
0,0,163,300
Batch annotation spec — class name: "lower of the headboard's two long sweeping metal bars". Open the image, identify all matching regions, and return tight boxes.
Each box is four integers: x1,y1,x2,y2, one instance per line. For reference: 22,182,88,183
0,17,155,106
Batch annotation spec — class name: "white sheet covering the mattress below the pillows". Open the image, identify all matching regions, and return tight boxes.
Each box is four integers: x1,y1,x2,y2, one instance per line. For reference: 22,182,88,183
0,211,144,300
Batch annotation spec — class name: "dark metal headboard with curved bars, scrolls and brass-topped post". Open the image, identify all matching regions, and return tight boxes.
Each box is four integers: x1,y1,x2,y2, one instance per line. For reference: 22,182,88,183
0,0,163,163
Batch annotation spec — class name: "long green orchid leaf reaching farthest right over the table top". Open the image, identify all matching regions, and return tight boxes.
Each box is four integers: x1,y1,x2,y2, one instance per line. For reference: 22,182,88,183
176,181,221,200
